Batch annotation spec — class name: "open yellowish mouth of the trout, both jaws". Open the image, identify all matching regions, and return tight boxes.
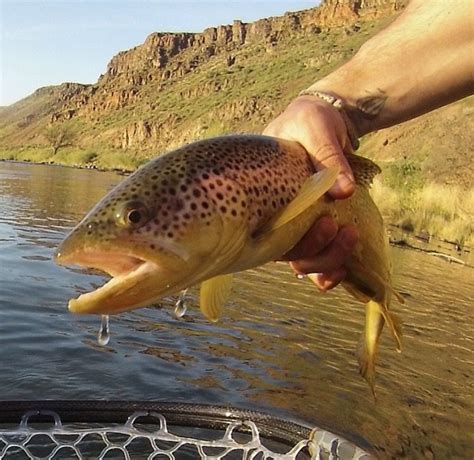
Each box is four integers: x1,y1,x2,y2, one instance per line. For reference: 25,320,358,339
55,251,161,315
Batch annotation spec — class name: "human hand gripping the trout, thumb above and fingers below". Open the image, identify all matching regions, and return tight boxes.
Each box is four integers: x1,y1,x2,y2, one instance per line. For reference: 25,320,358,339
263,96,358,291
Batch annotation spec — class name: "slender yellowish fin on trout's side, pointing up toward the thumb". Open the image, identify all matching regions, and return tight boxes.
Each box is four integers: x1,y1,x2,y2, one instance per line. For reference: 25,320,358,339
255,166,339,239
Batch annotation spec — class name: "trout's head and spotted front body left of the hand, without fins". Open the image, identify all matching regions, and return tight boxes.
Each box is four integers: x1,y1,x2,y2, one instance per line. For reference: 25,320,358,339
56,135,317,314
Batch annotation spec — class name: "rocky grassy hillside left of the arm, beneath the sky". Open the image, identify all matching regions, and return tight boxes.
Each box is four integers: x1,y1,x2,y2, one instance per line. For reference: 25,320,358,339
0,0,408,168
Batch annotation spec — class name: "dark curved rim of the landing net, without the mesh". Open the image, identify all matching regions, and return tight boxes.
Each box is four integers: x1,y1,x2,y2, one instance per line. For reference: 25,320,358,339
0,400,373,459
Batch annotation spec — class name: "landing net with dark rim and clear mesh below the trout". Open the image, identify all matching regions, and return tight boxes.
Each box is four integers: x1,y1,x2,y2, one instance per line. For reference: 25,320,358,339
0,401,372,460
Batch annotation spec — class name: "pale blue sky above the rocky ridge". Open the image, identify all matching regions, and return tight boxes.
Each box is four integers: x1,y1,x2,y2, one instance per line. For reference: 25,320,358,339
0,0,319,106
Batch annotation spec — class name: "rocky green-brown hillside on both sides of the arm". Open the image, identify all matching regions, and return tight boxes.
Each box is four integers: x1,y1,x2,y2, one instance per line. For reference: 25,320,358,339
0,0,474,244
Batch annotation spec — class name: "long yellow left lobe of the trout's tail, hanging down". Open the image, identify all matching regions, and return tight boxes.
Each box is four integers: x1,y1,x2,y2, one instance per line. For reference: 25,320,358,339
358,300,385,399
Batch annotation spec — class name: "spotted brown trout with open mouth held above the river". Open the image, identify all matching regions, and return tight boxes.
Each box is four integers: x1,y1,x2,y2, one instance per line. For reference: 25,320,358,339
55,134,403,395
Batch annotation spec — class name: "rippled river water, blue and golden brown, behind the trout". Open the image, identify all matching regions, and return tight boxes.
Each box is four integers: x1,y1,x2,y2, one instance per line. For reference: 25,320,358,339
0,162,474,459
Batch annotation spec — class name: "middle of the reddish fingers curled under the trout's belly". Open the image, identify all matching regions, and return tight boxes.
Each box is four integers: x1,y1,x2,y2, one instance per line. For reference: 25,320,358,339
290,226,358,274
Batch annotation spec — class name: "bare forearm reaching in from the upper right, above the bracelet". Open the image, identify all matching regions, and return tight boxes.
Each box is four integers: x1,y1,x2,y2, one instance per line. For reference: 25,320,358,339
304,0,474,136
